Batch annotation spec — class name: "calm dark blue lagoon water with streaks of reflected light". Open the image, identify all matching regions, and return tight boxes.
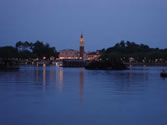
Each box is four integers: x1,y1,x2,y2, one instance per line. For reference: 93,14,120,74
0,65,167,125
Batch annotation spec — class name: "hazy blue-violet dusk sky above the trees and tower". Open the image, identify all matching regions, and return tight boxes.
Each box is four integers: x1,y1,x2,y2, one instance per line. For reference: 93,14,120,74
0,0,167,51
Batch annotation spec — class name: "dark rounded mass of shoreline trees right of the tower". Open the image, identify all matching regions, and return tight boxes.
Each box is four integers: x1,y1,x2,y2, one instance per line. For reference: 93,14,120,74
100,41,167,63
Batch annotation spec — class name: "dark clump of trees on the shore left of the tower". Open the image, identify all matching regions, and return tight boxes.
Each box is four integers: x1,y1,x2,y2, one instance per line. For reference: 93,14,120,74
0,41,58,59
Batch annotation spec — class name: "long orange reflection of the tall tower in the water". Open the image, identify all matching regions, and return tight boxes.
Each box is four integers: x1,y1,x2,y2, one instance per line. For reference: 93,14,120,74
80,68,84,104
